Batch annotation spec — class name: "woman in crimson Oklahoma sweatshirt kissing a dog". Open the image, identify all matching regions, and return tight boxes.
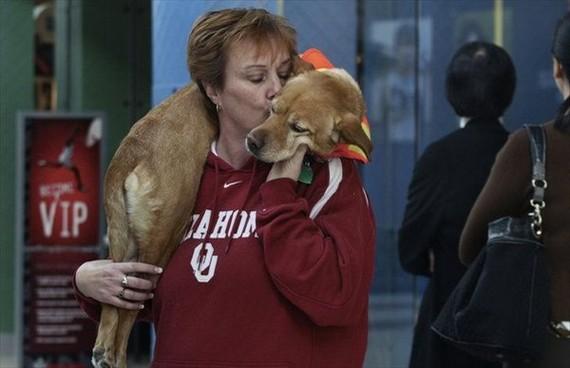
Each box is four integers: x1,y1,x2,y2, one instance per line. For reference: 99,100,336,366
75,9,375,368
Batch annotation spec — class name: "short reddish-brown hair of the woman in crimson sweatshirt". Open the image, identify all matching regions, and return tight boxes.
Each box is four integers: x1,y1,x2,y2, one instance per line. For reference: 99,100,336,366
187,8,297,116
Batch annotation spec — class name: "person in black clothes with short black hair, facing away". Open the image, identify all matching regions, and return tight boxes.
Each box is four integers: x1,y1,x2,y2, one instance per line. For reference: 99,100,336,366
398,42,516,368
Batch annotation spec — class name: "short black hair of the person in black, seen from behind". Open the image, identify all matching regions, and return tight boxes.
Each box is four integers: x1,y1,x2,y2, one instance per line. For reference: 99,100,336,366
445,41,516,119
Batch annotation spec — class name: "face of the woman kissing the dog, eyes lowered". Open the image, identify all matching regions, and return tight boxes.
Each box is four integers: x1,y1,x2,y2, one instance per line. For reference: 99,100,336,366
211,41,292,139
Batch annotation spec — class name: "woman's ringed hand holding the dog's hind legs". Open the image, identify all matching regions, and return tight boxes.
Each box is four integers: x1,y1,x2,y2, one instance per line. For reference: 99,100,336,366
75,259,162,310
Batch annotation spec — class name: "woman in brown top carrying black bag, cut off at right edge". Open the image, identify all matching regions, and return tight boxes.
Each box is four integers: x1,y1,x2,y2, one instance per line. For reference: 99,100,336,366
459,14,570,368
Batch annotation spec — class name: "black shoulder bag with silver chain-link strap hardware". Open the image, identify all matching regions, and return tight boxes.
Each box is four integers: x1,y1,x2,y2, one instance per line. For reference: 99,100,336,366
431,125,550,361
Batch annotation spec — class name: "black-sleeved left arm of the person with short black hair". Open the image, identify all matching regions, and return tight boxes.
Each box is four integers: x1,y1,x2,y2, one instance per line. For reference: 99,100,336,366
398,146,445,276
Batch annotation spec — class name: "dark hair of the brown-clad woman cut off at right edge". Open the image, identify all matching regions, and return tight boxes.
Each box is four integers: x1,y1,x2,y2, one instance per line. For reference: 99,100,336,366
552,13,570,132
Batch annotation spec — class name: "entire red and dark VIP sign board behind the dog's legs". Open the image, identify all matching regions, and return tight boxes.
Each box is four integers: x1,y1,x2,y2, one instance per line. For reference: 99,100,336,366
22,114,102,368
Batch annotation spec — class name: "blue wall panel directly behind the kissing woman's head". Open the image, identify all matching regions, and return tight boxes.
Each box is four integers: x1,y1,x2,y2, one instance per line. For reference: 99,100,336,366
152,0,357,105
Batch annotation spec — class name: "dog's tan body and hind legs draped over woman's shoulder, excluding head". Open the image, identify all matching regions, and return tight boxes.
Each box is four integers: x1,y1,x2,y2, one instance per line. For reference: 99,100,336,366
92,85,217,368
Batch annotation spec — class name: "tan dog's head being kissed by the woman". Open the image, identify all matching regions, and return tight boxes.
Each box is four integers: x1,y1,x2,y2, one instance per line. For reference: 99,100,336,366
246,69,372,162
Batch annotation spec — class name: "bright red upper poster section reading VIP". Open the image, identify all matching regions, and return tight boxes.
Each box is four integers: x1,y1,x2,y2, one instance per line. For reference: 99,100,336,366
26,118,101,245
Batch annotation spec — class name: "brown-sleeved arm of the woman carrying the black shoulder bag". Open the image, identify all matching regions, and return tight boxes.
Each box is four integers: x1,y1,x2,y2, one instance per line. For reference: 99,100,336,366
459,129,531,265
